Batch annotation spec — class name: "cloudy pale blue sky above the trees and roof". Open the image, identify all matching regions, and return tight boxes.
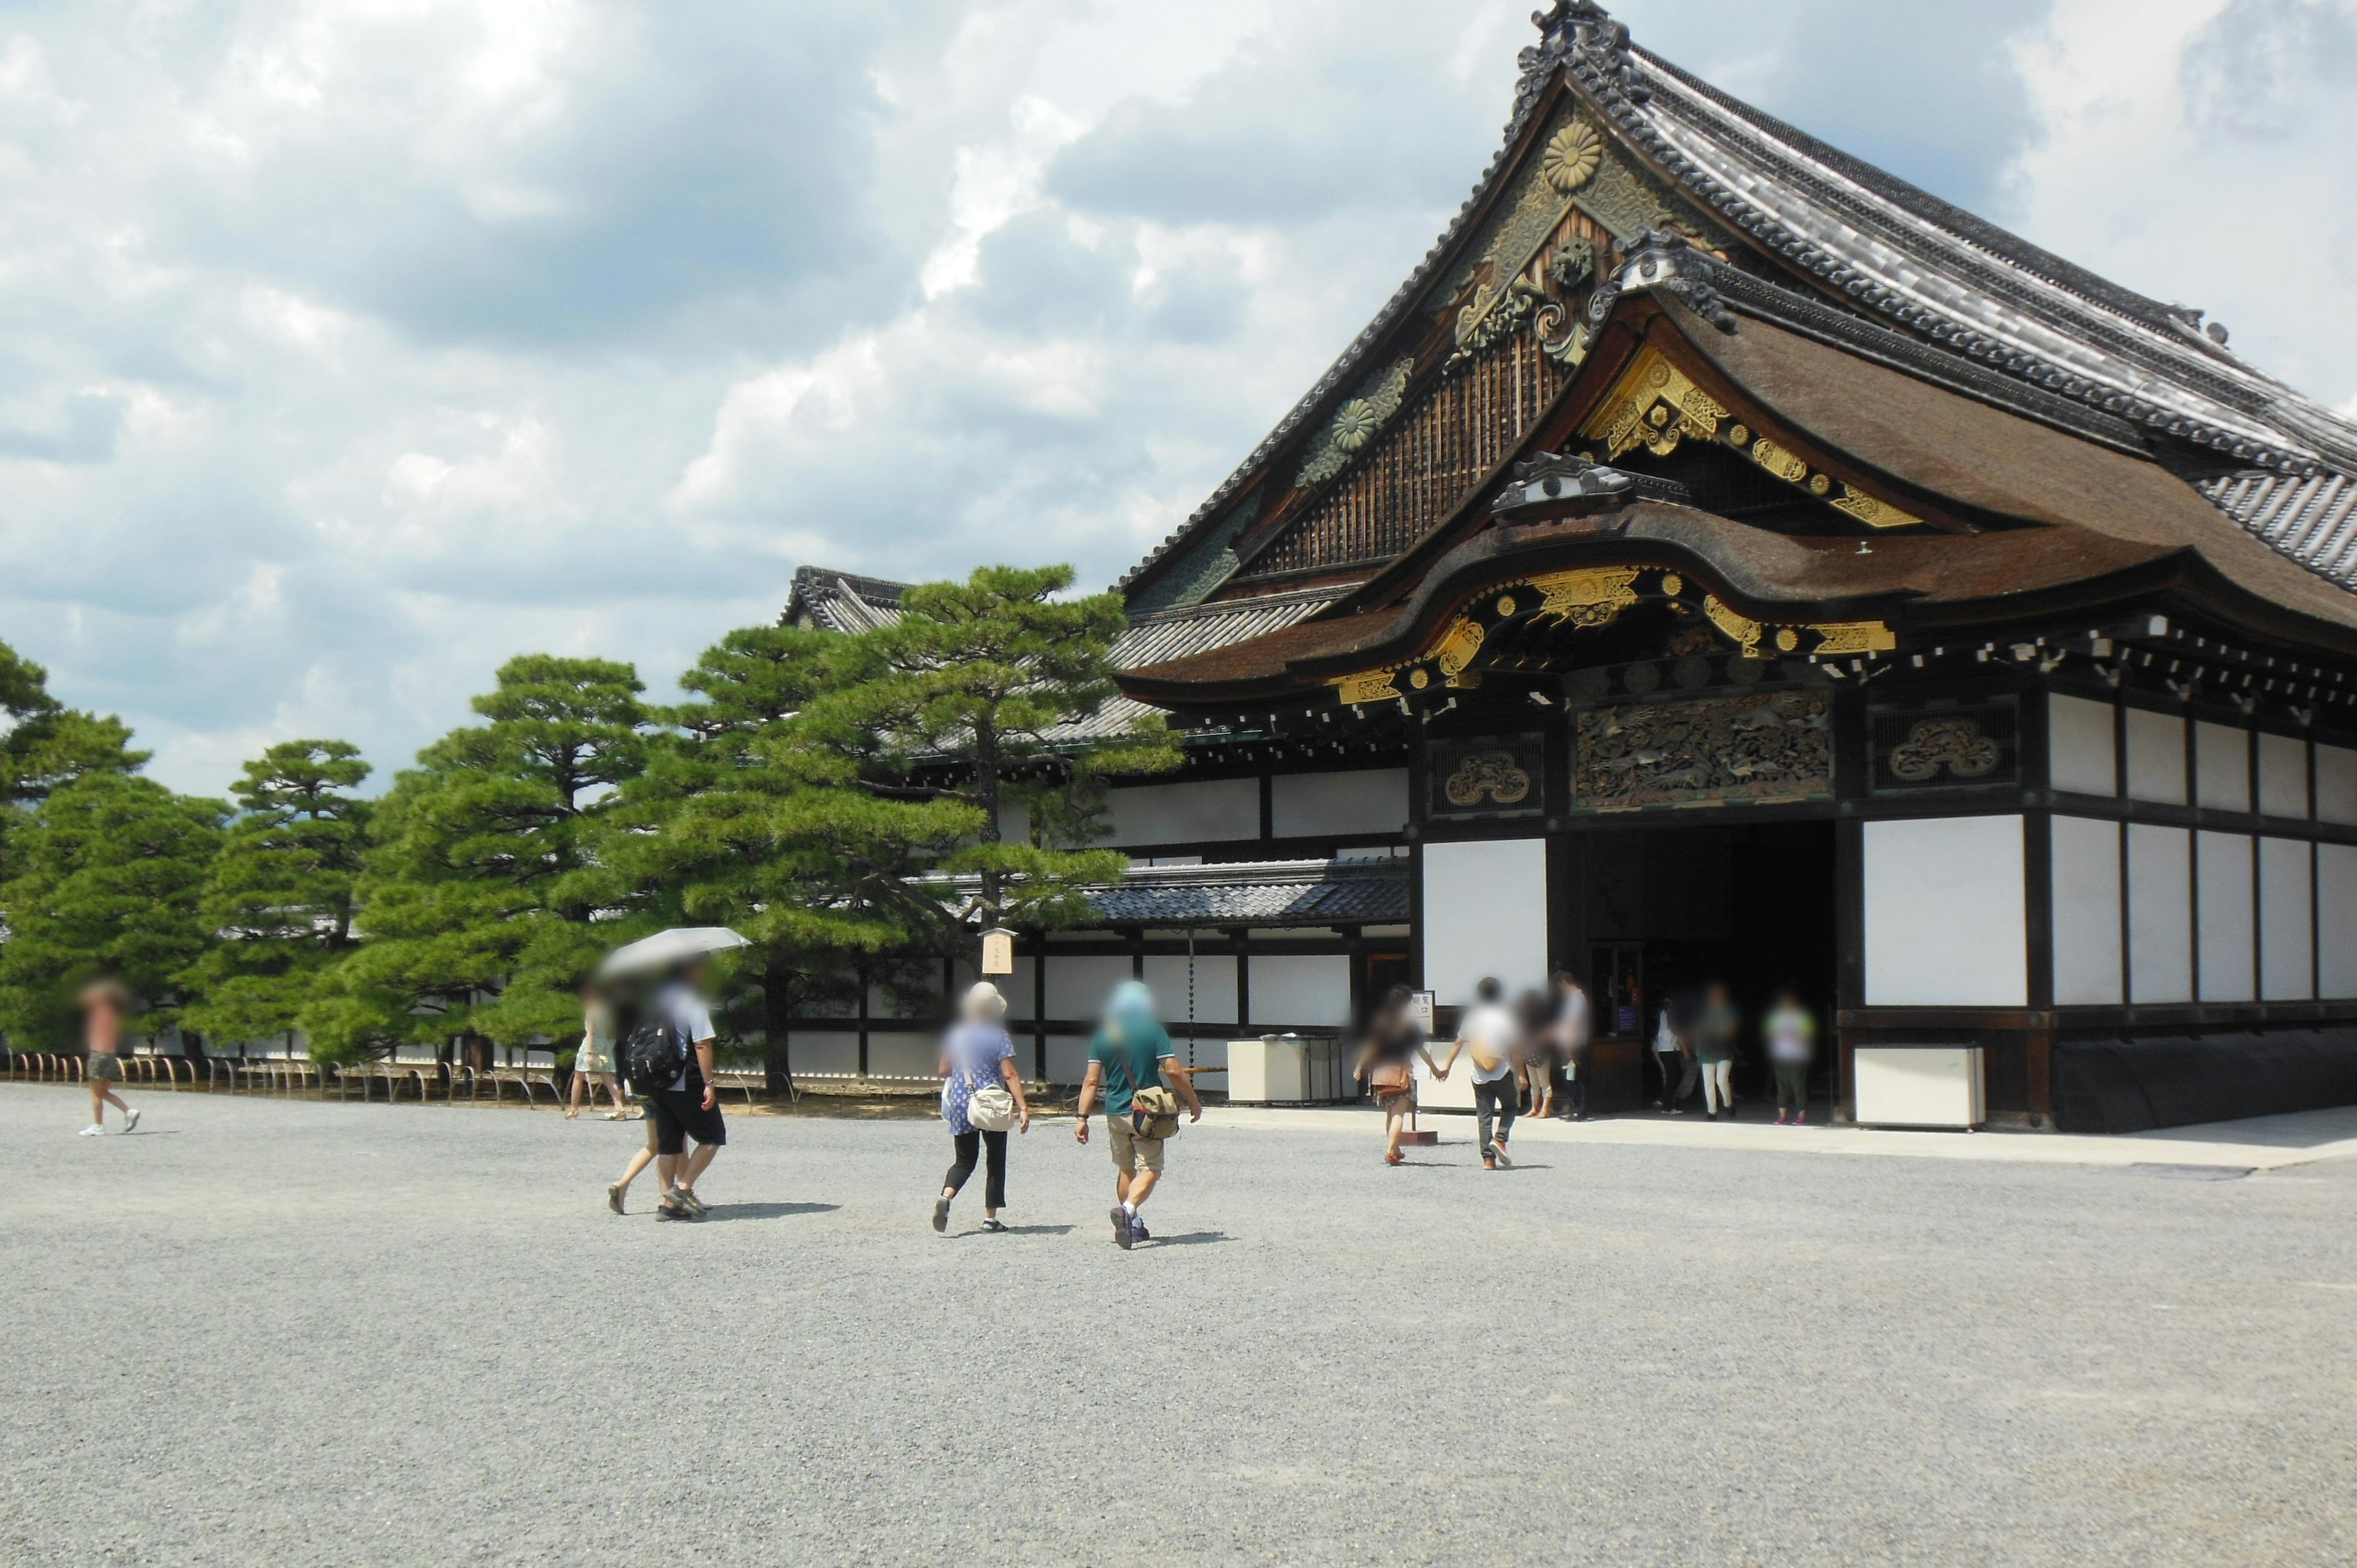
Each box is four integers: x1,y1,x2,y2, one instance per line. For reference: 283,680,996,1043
0,0,2357,792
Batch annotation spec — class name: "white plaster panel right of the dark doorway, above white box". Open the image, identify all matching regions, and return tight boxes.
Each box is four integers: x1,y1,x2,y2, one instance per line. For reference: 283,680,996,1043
1867,816,2029,1007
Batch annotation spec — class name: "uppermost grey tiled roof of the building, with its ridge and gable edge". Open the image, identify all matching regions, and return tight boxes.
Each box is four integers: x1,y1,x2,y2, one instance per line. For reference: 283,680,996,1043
1122,0,2357,603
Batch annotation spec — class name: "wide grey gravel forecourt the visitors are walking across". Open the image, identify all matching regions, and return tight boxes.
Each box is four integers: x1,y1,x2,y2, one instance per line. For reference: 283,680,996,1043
0,1084,2357,1568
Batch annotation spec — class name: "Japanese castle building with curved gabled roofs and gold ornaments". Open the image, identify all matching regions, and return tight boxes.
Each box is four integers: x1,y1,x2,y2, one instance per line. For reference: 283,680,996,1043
789,0,2357,1129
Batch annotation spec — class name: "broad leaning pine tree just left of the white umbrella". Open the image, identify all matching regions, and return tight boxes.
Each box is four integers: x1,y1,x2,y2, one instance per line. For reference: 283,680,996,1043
302,655,648,1052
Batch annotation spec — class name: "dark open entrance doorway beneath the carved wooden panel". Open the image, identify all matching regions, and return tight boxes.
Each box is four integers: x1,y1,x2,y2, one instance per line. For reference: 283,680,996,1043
1572,823,1836,1111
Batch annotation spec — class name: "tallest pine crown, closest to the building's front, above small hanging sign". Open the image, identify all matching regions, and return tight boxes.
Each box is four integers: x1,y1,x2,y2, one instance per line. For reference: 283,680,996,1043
788,566,1178,929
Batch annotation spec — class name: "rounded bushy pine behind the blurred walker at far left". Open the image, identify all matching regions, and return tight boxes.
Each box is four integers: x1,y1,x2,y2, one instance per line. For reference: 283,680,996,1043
0,771,228,1045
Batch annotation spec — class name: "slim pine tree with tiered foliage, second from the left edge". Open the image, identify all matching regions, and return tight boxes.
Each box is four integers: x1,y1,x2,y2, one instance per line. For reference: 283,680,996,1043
184,740,370,1056
